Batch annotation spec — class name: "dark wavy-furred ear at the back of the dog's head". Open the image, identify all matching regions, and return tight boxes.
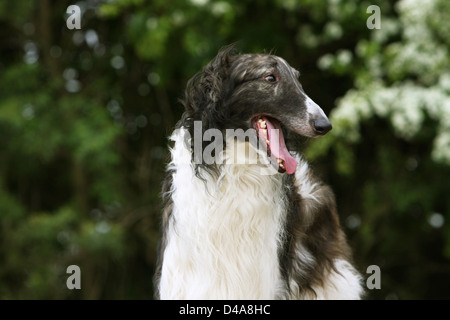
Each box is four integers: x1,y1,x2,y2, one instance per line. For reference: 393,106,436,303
183,44,236,115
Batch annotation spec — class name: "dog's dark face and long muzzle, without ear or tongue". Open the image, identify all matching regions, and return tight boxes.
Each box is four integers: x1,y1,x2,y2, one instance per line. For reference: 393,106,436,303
229,54,331,137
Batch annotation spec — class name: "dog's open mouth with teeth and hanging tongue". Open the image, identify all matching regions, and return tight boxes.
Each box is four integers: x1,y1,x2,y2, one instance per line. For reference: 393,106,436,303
253,115,297,174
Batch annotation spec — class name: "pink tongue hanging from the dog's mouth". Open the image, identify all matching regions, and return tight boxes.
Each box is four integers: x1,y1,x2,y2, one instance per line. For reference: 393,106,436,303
262,117,297,174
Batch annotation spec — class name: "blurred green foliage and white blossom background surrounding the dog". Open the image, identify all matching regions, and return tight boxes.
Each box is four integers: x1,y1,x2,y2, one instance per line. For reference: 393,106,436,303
0,0,450,299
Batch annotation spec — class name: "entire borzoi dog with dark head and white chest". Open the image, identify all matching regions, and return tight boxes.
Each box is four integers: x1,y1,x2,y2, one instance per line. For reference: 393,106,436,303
154,47,363,299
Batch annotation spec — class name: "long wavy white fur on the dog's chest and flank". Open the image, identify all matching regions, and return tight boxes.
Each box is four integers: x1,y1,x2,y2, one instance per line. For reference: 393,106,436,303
160,129,361,299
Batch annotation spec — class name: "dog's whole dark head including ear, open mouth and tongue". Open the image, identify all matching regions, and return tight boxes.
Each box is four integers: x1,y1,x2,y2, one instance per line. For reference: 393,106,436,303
184,47,332,173
